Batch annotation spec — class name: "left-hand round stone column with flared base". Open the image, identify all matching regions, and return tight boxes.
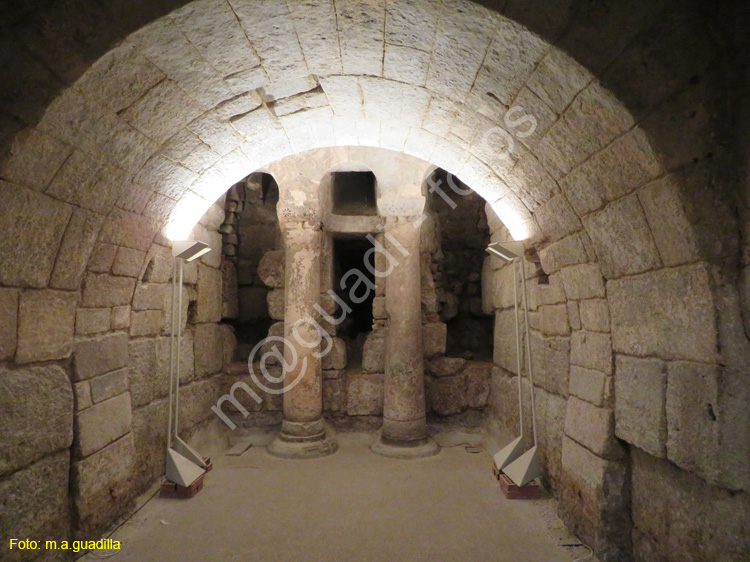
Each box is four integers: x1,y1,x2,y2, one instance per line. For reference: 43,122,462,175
268,217,338,458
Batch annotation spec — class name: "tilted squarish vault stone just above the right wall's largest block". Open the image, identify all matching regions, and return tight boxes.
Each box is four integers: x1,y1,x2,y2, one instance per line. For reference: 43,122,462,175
584,195,661,277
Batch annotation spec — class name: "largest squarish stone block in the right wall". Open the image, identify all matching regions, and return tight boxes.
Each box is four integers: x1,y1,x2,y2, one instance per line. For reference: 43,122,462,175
607,265,717,362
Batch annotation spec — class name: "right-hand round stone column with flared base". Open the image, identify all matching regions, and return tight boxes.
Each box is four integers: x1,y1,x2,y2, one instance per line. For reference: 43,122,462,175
372,214,439,457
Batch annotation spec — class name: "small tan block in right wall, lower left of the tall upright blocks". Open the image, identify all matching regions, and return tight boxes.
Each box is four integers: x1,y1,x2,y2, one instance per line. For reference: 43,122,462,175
565,396,623,459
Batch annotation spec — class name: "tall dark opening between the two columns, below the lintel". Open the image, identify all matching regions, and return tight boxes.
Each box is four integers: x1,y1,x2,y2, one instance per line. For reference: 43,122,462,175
333,237,375,366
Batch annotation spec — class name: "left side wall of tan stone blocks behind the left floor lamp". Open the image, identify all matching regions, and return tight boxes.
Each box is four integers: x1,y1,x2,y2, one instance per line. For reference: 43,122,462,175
0,196,231,558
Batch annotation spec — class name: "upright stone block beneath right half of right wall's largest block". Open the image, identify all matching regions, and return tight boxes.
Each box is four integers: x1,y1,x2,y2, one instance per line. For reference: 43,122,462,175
666,361,724,482
